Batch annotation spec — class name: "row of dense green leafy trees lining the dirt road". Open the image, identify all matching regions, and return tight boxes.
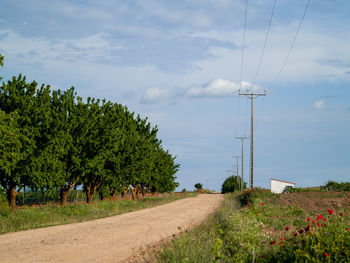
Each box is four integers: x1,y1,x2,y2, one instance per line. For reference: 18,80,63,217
0,57,179,209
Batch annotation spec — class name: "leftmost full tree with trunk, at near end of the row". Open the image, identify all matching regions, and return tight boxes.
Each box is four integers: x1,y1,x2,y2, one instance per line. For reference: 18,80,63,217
0,75,37,210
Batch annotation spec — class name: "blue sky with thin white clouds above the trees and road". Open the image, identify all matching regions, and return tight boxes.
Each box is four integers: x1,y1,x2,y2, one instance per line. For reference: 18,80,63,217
0,0,350,191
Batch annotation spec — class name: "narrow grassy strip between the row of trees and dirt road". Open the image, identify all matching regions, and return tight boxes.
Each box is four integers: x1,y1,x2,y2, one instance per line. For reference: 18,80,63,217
0,193,196,234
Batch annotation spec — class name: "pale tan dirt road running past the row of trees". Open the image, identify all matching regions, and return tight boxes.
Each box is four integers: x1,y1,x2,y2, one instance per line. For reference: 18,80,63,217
0,194,223,263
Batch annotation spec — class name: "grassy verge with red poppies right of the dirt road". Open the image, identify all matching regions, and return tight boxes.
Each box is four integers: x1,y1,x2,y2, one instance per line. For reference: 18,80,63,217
153,189,350,262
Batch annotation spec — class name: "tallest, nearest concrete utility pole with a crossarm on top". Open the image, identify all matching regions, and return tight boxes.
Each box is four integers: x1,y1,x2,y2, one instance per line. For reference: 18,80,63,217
239,90,266,189
